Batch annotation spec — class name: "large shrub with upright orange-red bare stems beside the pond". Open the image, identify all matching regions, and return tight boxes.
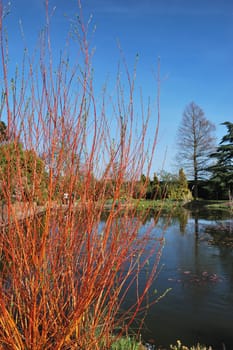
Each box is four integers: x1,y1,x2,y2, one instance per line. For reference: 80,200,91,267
0,1,164,350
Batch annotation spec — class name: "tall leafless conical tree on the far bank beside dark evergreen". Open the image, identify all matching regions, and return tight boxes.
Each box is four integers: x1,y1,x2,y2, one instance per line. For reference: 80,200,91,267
177,102,215,199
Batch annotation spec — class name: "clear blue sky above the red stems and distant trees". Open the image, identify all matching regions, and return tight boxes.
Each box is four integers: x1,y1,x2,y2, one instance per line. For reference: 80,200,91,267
2,0,233,171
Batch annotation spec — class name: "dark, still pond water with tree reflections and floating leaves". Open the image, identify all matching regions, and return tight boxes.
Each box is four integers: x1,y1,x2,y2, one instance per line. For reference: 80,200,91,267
124,212,233,350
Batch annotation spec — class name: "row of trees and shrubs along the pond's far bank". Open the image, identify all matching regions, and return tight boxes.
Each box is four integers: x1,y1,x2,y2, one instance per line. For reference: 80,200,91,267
0,115,233,202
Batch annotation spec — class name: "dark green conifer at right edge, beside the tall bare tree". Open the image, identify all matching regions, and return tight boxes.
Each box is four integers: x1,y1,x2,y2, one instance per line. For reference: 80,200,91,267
207,122,233,199
